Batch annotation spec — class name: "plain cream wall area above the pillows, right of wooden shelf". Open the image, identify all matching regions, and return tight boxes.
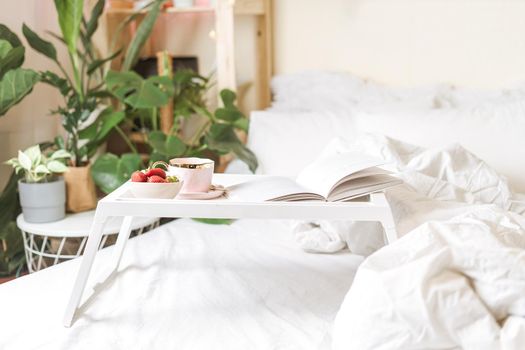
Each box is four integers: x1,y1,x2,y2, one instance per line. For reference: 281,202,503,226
274,0,525,87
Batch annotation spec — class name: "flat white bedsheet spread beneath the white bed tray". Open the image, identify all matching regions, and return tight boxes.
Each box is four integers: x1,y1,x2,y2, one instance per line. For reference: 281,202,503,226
0,219,362,350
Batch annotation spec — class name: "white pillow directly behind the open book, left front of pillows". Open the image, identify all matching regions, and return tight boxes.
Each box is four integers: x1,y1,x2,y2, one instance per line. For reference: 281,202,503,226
248,111,355,177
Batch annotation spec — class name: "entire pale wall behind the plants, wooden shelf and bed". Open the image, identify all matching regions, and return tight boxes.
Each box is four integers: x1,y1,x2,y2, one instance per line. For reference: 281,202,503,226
4,0,525,187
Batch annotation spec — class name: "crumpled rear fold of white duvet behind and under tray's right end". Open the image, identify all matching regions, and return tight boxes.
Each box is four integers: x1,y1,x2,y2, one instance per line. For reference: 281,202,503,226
293,134,525,256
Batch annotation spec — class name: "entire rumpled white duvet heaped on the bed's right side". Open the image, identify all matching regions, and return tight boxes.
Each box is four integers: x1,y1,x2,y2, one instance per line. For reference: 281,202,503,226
328,135,525,350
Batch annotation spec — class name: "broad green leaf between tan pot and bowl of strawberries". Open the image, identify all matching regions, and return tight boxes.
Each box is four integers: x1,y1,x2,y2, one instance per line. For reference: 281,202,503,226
91,153,142,193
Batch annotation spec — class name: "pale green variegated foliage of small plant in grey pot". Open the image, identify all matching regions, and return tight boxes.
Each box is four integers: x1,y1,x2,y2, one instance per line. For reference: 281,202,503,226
5,145,71,183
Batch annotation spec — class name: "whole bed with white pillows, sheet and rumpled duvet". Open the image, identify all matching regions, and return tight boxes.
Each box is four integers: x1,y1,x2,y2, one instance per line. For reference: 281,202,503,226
0,72,525,350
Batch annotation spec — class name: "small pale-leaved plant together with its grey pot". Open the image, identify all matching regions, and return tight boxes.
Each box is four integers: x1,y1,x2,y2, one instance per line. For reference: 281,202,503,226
6,145,71,222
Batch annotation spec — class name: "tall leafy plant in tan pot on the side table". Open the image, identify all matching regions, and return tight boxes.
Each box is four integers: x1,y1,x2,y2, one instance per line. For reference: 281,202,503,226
23,0,162,212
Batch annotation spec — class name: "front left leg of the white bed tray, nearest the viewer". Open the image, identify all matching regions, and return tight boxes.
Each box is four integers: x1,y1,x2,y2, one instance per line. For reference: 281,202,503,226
63,210,106,327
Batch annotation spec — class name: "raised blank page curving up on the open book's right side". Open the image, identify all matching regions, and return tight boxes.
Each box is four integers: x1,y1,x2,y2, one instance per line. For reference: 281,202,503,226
297,152,384,198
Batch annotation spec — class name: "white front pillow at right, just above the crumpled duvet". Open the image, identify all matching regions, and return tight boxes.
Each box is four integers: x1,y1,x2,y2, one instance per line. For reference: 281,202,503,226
355,100,525,192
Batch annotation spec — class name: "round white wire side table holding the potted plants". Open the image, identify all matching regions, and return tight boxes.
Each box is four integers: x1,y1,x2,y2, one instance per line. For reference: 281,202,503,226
16,210,159,273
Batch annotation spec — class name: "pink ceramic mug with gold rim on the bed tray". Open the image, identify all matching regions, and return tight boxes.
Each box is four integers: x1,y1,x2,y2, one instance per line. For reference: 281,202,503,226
168,157,214,193
